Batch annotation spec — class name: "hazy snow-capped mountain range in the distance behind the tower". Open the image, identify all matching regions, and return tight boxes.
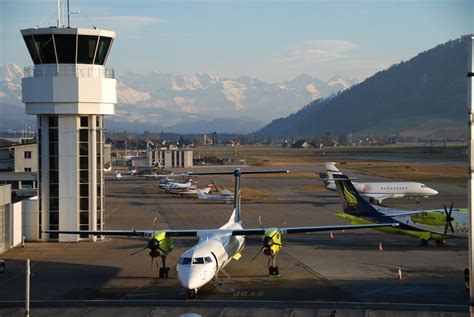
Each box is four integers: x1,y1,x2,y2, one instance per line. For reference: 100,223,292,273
0,65,357,133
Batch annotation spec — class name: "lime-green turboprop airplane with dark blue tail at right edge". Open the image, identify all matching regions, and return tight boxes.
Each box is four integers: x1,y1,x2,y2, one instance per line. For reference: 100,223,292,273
334,175,469,245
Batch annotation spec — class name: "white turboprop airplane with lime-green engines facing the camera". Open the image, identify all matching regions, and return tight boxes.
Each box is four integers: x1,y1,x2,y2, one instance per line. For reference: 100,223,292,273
45,169,398,299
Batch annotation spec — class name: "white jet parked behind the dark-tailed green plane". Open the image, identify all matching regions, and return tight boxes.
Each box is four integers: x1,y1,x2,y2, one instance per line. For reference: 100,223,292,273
319,162,438,204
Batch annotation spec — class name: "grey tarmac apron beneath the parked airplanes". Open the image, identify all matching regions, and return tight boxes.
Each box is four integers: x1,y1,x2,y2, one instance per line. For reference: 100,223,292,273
0,166,469,317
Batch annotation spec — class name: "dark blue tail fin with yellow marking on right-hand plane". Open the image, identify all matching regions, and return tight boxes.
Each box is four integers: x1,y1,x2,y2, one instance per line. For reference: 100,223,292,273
334,174,383,218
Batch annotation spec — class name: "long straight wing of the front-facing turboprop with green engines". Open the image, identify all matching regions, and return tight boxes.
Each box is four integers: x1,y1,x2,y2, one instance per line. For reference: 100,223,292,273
47,222,399,237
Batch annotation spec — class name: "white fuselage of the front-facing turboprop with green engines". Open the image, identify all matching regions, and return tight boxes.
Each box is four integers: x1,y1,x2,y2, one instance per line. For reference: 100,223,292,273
176,223,245,290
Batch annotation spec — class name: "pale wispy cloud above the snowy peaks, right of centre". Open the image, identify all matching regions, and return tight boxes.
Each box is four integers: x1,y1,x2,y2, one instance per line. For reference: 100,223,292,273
282,40,357,64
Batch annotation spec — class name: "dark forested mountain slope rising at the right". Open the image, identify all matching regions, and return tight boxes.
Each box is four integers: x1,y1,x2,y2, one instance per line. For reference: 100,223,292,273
257,36,469,138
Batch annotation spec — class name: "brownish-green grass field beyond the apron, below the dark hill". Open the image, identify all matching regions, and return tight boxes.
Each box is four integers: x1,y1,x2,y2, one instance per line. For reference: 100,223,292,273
195,144,467,182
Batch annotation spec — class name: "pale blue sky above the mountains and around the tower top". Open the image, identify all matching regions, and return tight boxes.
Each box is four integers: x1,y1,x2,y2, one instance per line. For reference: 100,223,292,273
0,0,474,82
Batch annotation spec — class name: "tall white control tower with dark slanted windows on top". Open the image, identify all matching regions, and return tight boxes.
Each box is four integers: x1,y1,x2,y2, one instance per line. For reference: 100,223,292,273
21,10,117,241
